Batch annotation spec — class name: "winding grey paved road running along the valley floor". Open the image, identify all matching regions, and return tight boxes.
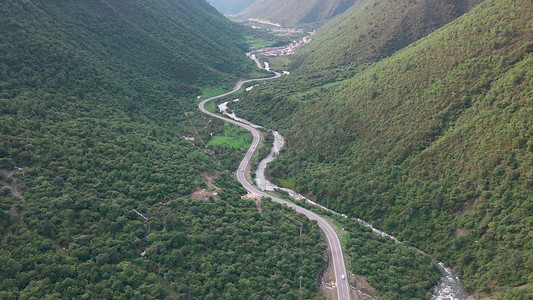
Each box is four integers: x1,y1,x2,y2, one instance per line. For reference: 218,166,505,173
198,68,350,300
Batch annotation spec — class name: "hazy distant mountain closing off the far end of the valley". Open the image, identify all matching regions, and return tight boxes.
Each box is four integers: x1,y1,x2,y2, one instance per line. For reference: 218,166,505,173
238,0,356,26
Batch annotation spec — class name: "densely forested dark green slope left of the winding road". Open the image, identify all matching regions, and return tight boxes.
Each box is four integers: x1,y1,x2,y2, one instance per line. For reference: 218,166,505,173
0,0,324,299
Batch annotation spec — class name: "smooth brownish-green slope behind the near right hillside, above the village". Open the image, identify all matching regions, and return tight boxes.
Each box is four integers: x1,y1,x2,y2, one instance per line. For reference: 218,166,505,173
292,0,482,76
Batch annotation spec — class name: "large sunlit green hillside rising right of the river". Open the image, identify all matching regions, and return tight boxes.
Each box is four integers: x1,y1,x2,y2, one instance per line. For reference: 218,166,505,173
238,0,533,299
